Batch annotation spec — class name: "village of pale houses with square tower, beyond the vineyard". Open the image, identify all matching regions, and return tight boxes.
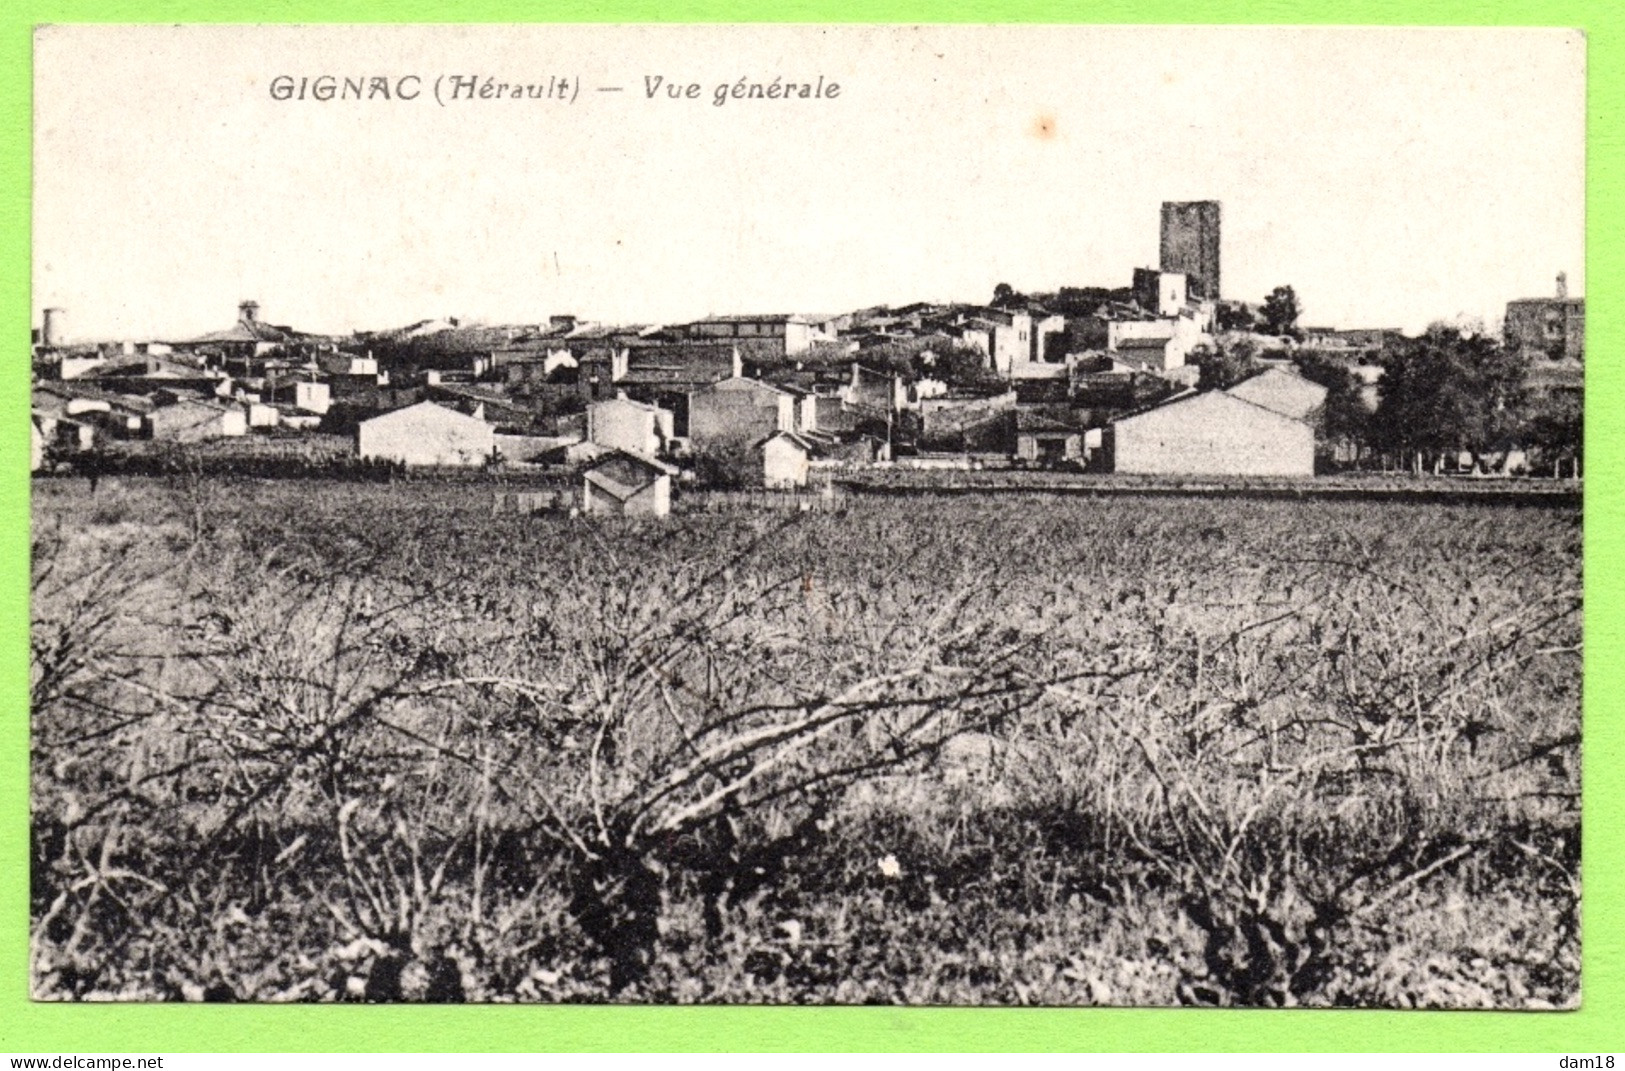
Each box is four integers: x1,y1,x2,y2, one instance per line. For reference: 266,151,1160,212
33,202,1584,514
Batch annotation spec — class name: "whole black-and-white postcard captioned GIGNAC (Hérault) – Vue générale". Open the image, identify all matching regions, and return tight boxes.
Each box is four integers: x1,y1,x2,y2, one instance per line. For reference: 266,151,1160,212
31,24,1586,1012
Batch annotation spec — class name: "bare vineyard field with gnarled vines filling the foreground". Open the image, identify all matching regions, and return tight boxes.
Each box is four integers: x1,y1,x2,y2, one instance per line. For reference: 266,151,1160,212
31,478,1581,1008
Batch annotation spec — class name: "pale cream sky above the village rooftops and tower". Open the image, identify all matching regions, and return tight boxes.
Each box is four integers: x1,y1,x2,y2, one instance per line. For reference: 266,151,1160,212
34,26,1584,340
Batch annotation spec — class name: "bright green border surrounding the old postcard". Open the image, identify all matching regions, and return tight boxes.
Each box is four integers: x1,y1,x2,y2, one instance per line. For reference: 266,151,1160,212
0,0,1625,1053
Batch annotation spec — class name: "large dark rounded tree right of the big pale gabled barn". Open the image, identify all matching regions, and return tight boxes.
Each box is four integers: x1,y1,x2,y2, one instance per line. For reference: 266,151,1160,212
1372,323,1524,466
